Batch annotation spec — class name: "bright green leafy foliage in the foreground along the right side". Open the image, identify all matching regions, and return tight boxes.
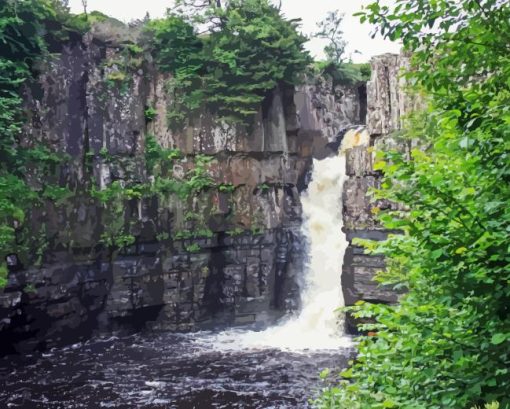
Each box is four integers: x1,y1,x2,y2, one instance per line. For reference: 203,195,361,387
316,0,510,409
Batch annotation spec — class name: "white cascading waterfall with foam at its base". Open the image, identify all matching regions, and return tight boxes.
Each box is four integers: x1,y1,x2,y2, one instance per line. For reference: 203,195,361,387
209,130,369,351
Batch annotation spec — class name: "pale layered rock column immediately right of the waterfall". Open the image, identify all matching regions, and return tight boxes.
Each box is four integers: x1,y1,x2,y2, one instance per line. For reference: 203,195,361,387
342,54,419,332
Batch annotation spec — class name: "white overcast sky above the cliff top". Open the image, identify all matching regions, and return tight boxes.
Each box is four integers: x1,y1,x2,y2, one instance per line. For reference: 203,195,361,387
69,0,400,62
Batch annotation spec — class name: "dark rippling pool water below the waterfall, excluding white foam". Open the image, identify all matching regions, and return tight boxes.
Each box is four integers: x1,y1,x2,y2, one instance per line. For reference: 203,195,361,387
0,333,352,409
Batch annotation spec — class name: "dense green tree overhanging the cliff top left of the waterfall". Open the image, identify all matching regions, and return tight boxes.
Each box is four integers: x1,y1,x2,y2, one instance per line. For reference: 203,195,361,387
148,0,310,127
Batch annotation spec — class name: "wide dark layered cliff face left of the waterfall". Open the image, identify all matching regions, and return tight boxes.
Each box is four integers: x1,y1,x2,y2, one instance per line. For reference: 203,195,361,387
0,29,366,352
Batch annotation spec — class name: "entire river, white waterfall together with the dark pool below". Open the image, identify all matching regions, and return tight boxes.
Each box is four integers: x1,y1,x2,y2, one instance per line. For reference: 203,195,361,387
0,130,368,409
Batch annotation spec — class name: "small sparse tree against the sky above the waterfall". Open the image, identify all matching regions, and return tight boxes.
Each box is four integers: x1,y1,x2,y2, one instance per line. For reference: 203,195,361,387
314,10,347,65
